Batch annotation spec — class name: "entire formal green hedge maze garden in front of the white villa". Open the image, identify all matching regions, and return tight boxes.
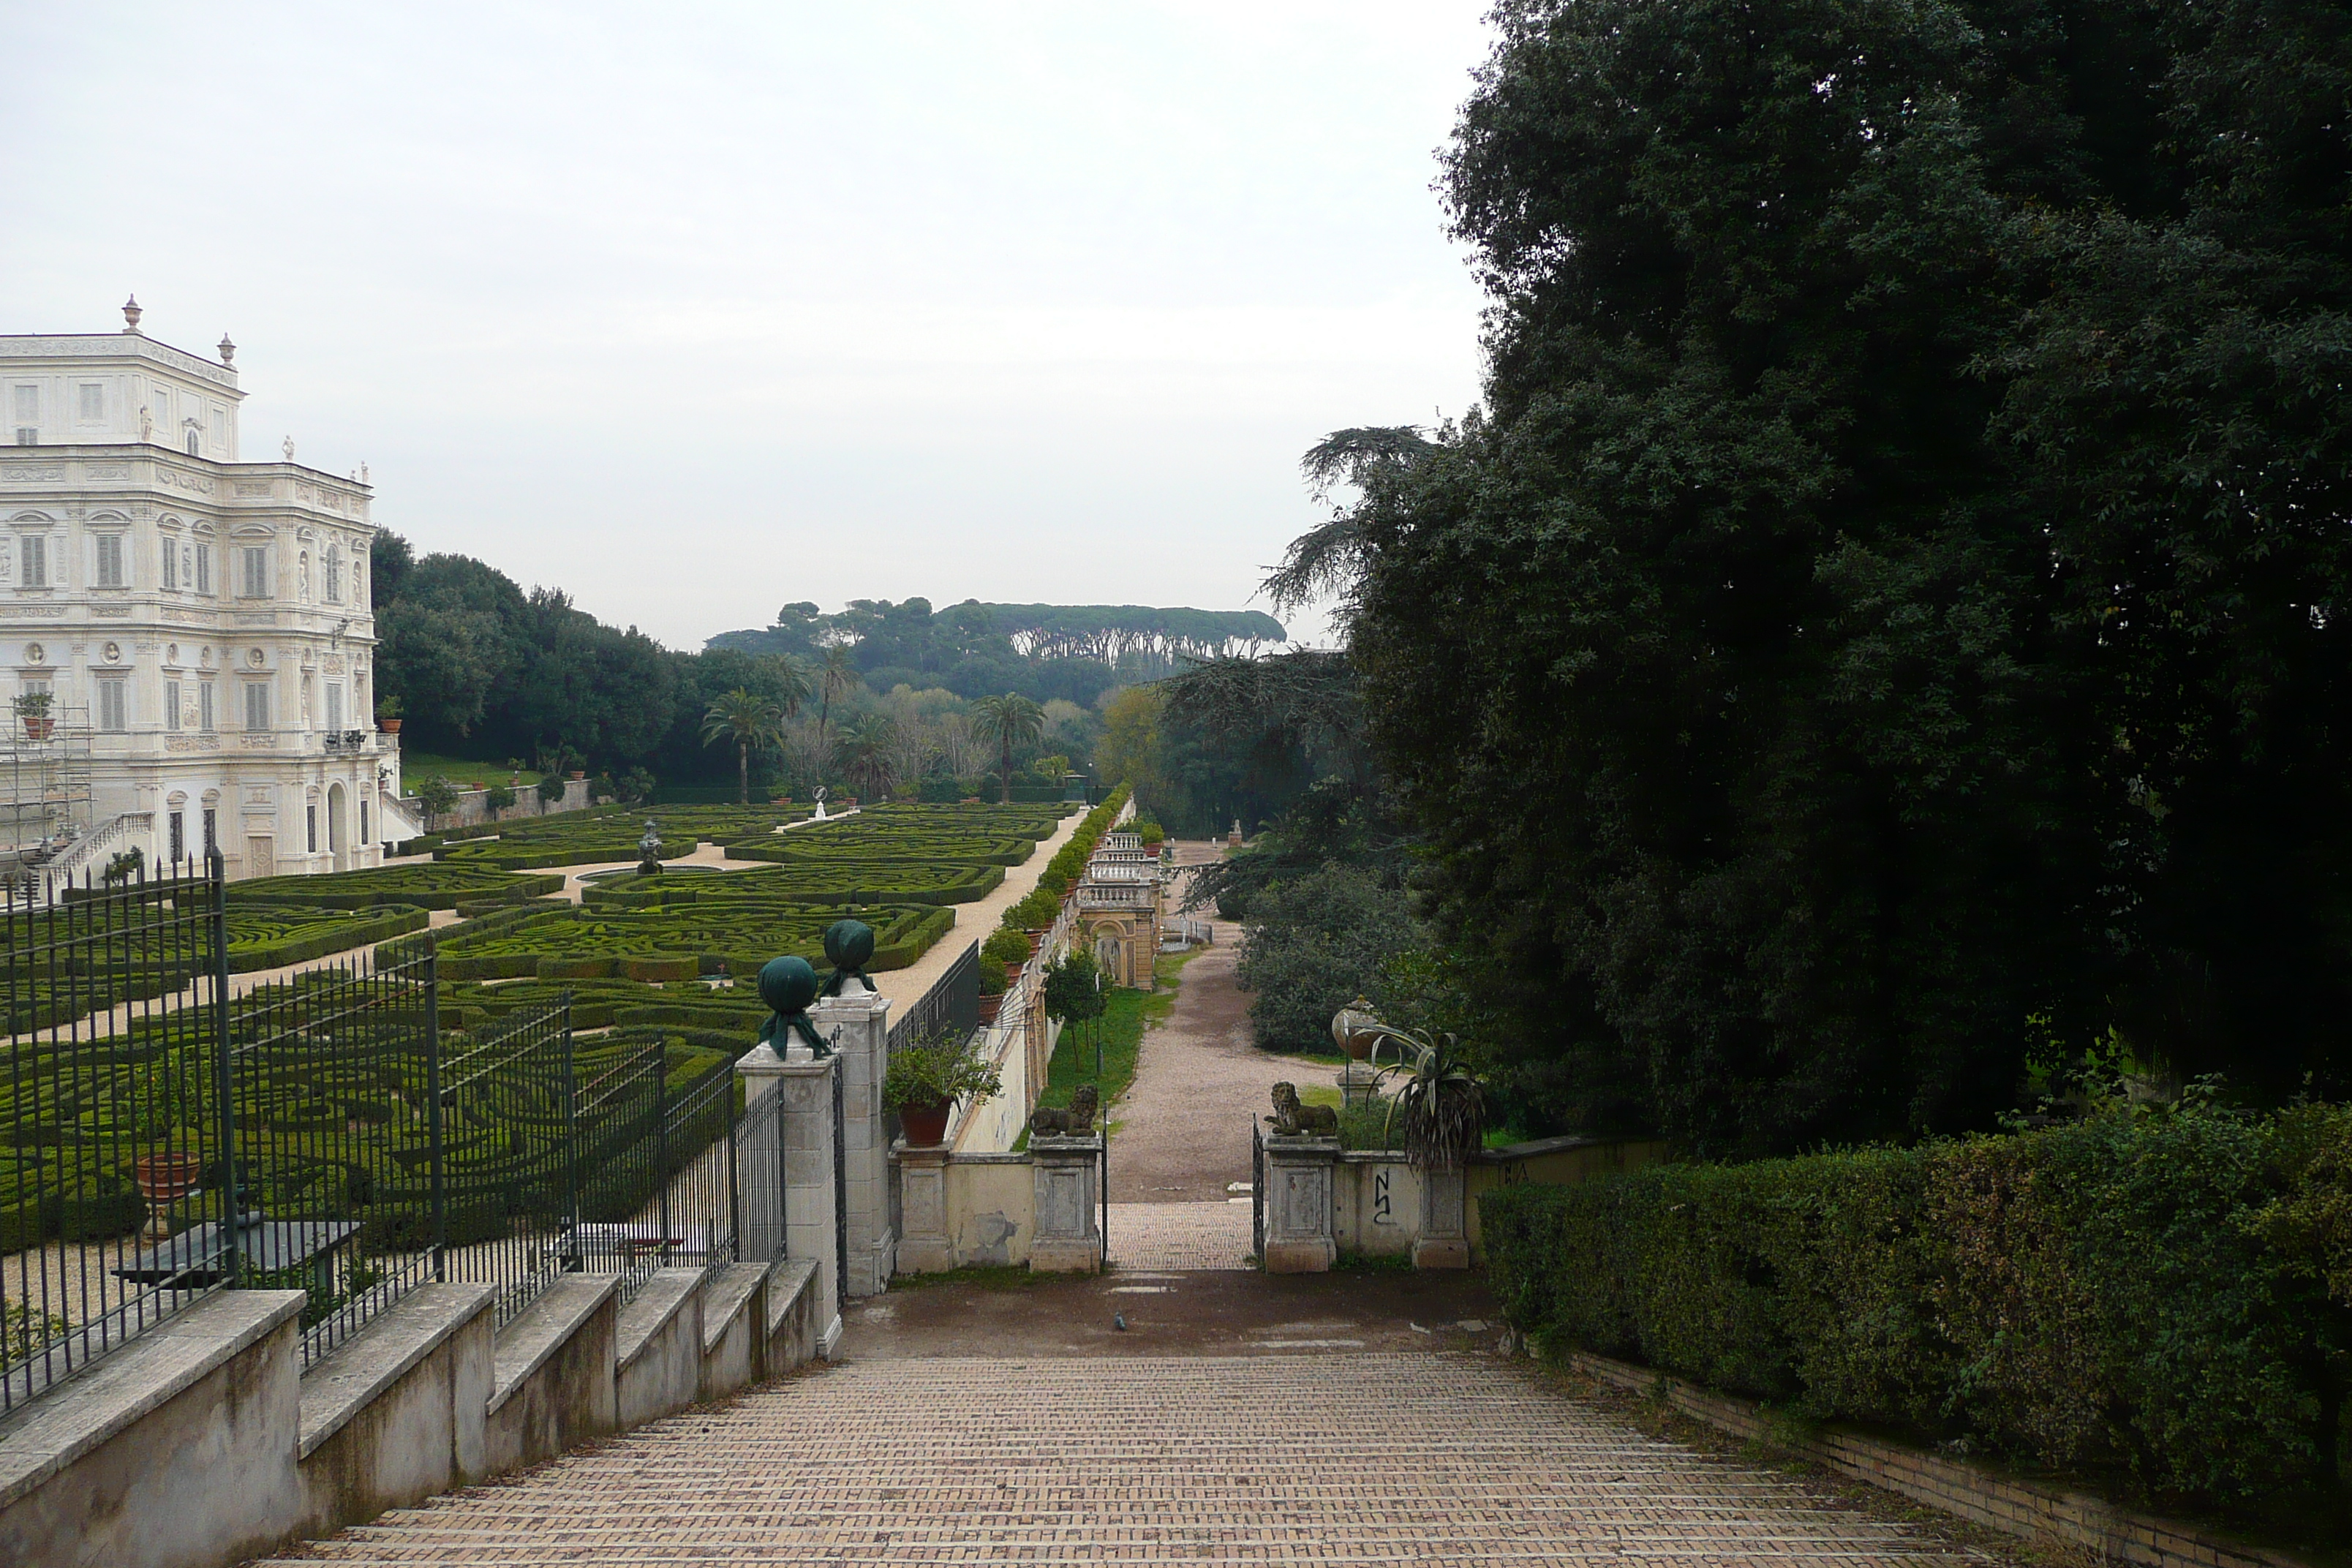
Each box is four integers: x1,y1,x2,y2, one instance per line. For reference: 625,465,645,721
0,804,1066,1251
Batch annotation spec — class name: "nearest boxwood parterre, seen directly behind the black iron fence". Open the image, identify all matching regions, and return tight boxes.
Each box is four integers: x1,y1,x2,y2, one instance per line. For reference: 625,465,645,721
0,976,743,1253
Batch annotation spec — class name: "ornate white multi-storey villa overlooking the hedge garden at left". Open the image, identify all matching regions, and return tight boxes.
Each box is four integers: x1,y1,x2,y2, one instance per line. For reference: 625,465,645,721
0,301,398,879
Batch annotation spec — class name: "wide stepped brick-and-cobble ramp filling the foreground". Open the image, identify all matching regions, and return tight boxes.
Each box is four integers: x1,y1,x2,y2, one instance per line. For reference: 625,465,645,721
257,1354,1988,1568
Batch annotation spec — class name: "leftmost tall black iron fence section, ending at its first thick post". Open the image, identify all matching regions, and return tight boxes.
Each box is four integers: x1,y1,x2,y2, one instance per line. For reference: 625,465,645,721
0,860,228,1411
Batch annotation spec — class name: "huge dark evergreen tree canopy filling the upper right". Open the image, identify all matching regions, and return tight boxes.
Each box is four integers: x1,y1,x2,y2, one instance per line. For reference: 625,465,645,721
1326,0,2352,1152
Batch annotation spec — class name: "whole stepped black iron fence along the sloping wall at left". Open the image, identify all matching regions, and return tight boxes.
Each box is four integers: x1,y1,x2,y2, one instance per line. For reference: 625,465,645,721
0,856,761,1411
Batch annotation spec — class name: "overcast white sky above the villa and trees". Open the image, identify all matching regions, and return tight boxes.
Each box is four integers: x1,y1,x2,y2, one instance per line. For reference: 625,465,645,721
0,0,1487,647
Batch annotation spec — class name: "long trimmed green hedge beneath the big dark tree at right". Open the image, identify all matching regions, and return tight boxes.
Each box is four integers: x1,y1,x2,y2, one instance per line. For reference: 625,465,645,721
1480,1107,2352,1504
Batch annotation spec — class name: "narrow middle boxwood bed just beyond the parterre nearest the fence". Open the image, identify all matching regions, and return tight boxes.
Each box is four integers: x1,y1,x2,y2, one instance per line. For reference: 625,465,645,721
440,898,955,980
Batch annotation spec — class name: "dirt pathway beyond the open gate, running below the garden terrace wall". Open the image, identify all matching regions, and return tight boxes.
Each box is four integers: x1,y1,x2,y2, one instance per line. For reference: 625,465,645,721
1110,844,1331,1204
